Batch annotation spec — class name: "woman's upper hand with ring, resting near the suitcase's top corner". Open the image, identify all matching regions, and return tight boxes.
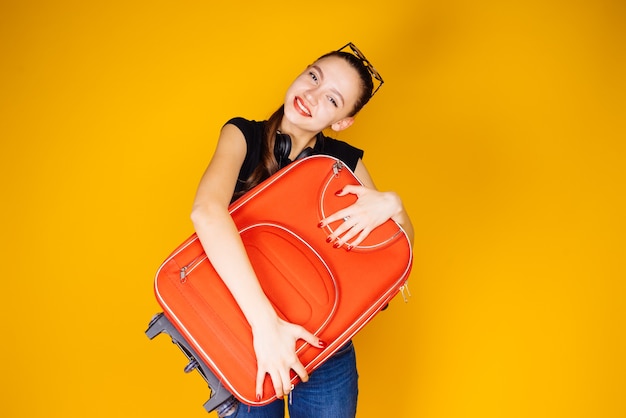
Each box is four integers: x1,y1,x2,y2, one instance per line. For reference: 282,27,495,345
319,185,403,250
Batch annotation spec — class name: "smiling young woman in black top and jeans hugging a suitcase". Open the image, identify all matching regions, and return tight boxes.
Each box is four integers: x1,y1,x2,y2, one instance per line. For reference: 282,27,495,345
191,44,413,418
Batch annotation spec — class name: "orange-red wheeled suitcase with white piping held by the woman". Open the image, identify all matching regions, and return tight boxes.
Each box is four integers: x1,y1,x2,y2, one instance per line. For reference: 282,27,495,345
146,155,412,412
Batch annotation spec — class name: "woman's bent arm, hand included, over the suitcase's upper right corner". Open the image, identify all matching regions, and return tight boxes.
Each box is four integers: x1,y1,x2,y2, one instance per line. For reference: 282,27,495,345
322,160,414,248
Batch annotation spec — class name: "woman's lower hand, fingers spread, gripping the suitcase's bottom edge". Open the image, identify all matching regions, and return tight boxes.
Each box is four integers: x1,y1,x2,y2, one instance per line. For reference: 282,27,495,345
252,316,324,400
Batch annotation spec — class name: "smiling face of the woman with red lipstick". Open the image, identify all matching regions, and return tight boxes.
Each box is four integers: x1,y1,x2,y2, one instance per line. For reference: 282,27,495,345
283,56,362,134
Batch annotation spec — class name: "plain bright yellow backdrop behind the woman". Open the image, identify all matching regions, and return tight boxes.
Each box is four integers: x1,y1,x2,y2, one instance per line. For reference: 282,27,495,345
0,0,626,418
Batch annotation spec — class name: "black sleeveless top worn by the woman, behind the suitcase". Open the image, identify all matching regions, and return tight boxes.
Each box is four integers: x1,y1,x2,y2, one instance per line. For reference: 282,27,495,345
226,117,364,198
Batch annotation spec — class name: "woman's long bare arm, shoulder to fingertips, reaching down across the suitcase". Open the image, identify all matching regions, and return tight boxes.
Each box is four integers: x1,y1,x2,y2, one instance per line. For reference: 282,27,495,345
191,125,321,398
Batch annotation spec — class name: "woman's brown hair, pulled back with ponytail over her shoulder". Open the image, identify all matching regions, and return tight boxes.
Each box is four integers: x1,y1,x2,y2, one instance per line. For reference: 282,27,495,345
236,51,374,197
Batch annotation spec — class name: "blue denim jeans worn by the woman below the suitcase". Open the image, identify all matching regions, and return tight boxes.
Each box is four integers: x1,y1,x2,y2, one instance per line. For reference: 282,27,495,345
228,342,359,418
